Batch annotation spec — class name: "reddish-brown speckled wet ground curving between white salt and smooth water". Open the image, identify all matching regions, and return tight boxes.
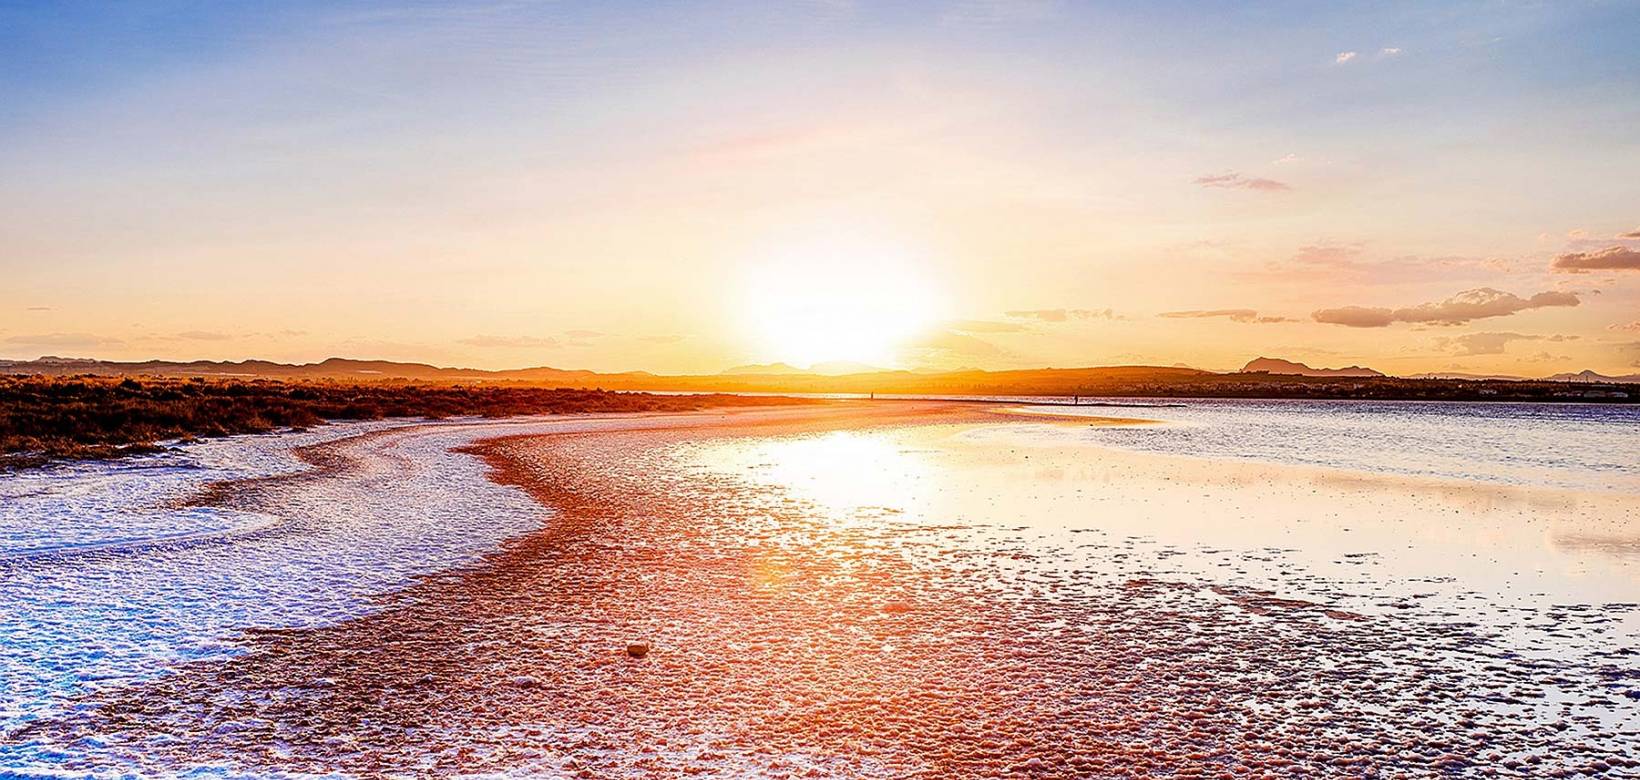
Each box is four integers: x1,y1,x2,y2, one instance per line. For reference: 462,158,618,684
21,403,1640,777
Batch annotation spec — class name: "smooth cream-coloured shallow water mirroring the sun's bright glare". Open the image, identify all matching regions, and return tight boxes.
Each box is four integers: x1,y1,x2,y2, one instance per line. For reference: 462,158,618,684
692,418,1640,632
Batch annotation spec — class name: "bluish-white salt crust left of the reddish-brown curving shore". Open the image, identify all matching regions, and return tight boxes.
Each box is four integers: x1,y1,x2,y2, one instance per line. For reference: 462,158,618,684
0,414,564,737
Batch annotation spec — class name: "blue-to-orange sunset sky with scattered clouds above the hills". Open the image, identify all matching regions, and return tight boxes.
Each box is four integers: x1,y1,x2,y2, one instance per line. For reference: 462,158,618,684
0,0,1640,375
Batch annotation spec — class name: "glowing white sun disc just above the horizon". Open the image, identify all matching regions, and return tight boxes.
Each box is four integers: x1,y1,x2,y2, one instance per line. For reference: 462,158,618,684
745,244,936,367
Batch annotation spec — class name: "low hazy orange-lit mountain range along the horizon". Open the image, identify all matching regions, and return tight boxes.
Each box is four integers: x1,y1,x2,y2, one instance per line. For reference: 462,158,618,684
0,357,1640,388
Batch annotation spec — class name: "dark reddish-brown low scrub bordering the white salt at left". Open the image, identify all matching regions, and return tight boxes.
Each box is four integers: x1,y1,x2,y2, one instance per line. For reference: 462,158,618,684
0,377,795,469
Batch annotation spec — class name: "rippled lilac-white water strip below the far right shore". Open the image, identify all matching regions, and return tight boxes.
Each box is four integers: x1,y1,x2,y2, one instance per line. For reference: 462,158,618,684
1027,398,1640,493
